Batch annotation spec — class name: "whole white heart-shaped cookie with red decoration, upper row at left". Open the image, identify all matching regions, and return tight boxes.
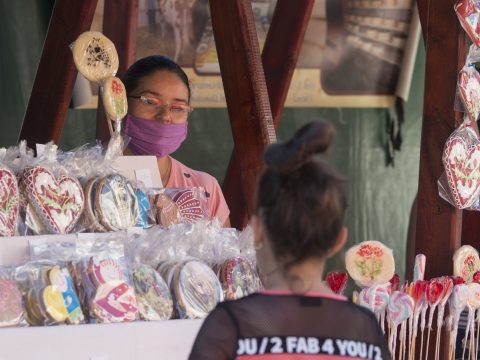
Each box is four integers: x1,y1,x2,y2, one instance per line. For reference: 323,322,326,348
23,166,84,234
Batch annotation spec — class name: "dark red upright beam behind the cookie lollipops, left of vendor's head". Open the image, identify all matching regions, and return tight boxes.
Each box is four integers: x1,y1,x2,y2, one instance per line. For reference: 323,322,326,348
97,0,138,143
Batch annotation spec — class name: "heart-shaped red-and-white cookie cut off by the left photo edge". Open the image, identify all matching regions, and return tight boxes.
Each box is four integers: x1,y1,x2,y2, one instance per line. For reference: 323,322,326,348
0,168,20,236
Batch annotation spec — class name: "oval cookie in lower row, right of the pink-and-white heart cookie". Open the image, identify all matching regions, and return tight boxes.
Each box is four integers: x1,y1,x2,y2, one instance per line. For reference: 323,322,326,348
133,265,173,320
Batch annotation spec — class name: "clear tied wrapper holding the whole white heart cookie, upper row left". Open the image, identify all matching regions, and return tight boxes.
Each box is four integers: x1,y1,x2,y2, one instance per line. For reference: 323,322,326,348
22,144,84,234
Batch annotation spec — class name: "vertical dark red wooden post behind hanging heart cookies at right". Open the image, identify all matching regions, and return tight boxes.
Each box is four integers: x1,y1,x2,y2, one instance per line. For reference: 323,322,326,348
415,0,467,359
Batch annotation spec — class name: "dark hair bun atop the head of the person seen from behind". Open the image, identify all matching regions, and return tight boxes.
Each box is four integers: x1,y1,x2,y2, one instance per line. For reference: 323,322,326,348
263,121,335,173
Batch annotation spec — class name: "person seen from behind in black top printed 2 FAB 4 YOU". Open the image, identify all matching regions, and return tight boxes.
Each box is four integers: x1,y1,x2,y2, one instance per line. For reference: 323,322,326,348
190,123,391,360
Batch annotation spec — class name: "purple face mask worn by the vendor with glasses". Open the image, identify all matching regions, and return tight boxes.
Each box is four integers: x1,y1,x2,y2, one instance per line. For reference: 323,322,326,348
125,114,188,158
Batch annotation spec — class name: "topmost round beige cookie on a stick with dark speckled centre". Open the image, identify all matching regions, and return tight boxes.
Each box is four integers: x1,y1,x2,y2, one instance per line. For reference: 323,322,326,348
72,31,118,82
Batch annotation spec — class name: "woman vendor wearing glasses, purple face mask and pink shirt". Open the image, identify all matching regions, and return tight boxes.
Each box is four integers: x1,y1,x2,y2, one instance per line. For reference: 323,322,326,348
123,55,230,226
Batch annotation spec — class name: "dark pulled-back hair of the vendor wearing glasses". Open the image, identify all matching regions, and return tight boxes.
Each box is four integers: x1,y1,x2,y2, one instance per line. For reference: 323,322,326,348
123,55,191,101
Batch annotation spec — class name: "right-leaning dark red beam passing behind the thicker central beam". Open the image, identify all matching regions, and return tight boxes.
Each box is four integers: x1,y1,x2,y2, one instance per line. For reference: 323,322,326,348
223,0,314,229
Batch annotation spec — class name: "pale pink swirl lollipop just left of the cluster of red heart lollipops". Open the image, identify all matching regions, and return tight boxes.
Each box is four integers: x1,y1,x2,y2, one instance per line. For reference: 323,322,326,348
387,291,415,355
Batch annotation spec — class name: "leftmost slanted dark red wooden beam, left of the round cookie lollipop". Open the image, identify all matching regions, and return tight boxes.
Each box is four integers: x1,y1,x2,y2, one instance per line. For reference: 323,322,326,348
19,0,97,148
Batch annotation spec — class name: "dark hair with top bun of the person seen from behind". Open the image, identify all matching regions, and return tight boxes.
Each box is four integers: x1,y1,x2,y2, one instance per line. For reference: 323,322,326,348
255,122,347,268
